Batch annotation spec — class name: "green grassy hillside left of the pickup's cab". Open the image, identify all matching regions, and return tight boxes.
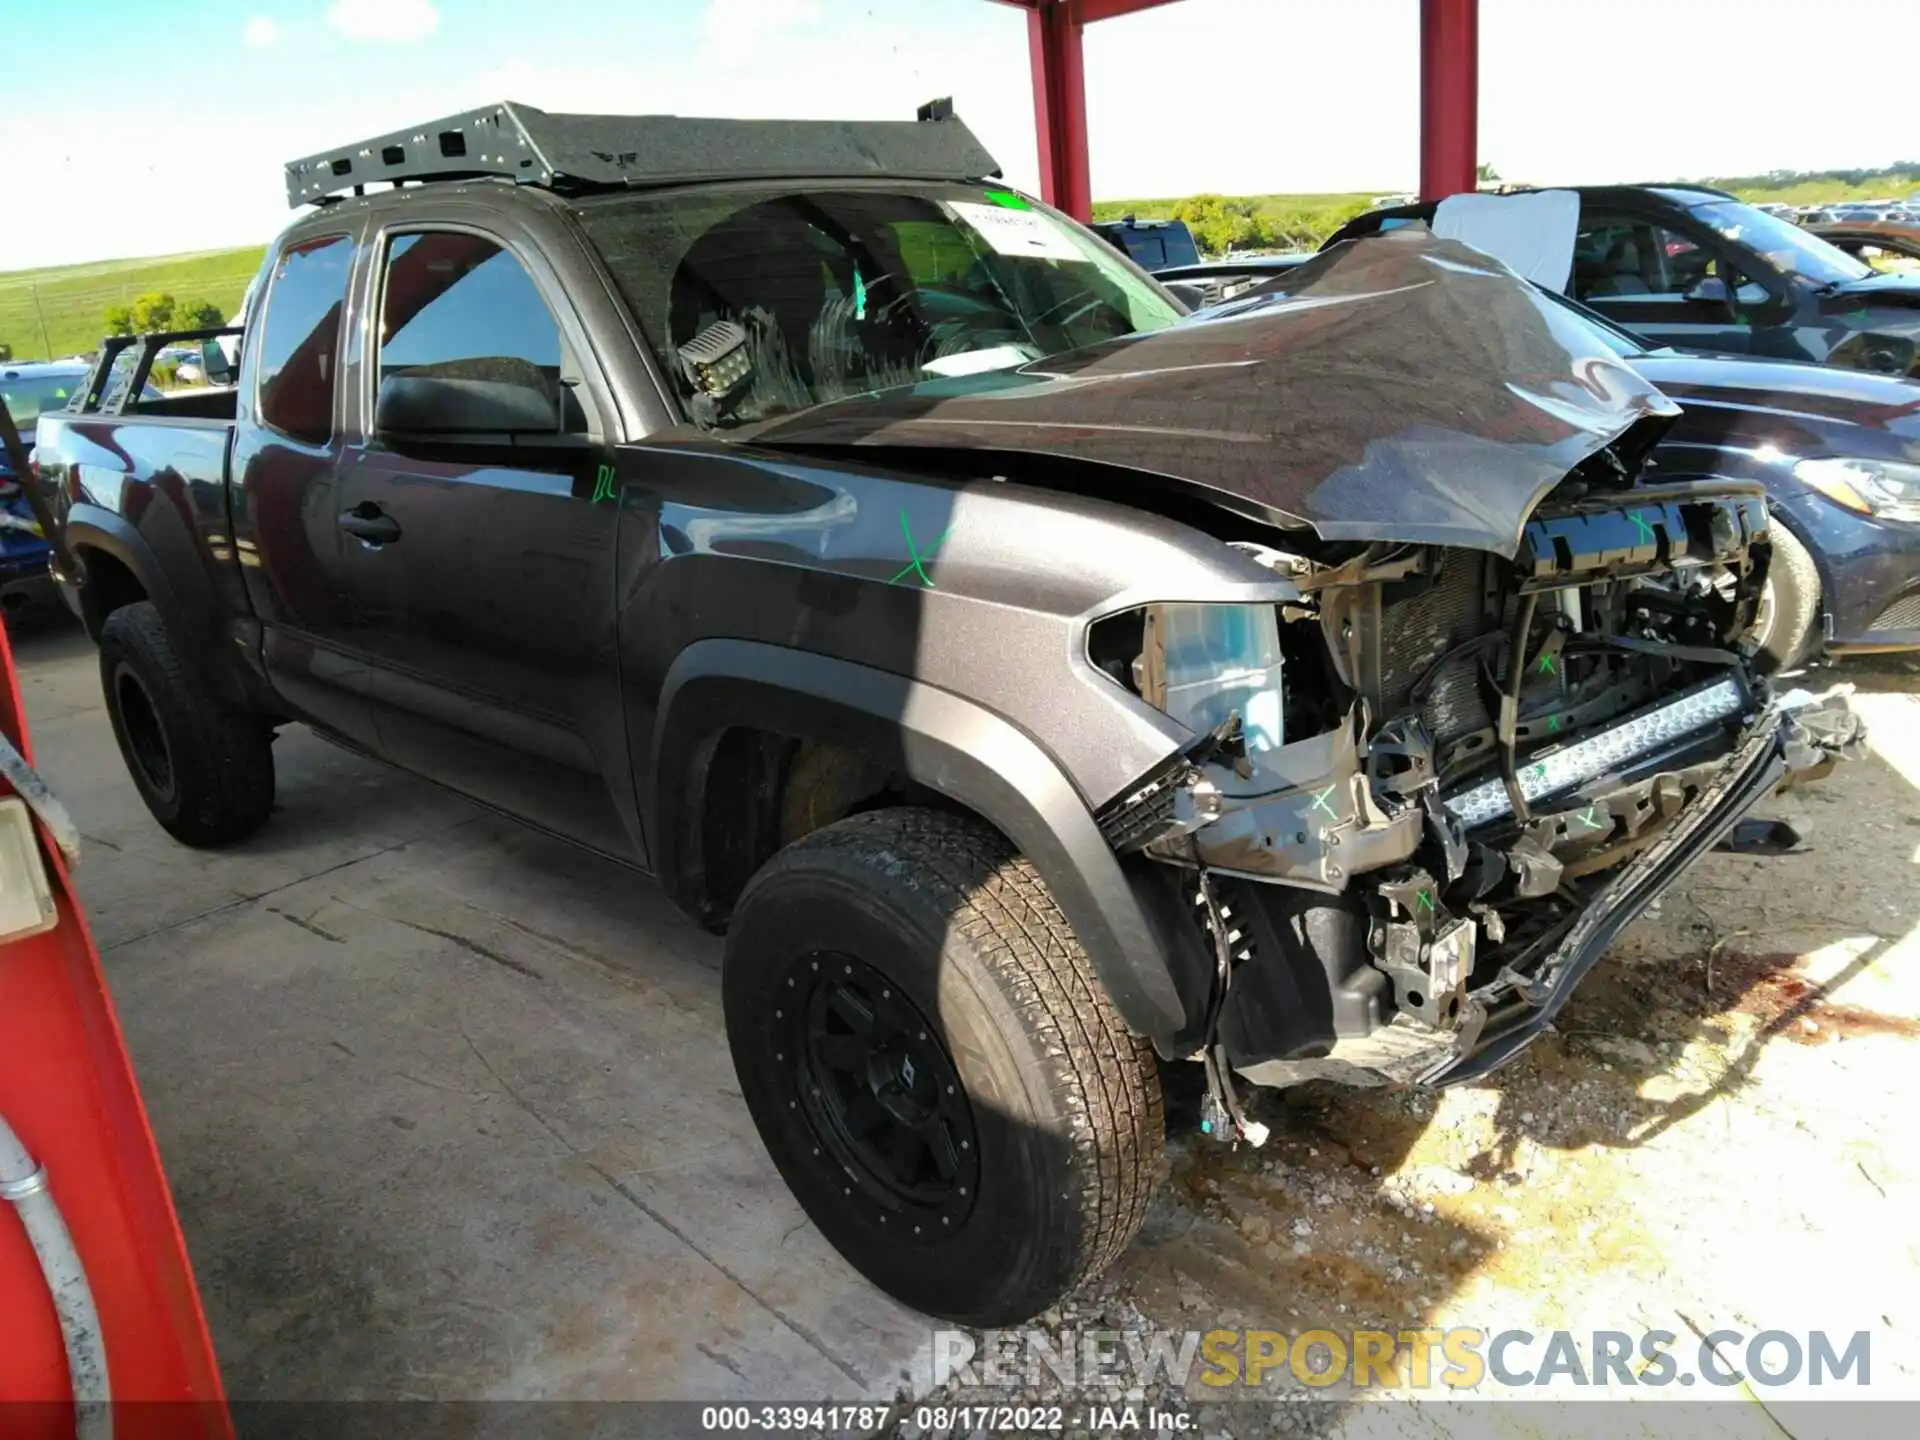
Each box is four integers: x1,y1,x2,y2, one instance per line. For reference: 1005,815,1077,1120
0,246,265,359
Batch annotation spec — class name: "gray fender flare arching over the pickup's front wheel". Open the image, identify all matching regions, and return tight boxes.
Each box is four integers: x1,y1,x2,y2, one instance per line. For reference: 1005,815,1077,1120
641,639,1208,1048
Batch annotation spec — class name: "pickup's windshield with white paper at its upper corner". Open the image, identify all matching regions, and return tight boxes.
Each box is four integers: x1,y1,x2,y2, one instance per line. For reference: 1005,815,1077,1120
578,184,1181,428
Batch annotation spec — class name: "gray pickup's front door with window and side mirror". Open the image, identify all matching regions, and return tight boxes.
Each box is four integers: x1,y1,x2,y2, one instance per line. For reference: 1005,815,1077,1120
338,225,643,860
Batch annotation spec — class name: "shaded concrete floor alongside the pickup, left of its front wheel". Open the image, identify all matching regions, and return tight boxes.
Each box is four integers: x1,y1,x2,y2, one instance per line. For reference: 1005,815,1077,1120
15,626,931,1400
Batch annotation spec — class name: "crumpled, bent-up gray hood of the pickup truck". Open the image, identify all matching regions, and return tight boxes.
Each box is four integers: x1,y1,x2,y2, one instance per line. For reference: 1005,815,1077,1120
748,228,1678,557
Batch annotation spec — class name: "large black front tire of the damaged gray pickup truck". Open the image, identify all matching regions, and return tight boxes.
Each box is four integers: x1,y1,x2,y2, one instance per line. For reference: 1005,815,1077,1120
724,808,1165,1325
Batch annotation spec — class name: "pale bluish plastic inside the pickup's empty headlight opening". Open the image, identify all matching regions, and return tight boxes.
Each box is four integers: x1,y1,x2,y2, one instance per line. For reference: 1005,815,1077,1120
1133,603,1284,755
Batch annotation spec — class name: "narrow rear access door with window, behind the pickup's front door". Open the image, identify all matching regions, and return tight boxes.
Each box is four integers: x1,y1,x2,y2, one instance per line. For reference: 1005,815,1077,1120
230,225,378,751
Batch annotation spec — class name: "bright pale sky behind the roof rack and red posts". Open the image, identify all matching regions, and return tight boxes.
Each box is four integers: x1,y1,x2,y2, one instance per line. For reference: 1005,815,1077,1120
0,0,1920,269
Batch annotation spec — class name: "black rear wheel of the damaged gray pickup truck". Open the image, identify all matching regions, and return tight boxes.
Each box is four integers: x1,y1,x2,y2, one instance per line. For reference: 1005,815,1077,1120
100,601,273,845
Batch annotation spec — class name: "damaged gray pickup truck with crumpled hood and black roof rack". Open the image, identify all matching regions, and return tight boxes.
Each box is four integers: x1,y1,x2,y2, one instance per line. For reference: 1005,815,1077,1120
38,106,1859,1323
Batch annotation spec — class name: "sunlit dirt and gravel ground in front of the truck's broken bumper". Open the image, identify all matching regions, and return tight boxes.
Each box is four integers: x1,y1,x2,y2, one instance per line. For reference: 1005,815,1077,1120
910,660,1920,1440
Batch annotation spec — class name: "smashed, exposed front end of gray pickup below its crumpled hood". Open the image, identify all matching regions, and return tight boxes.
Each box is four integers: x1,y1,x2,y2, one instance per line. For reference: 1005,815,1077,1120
1091,474,1857,1083
